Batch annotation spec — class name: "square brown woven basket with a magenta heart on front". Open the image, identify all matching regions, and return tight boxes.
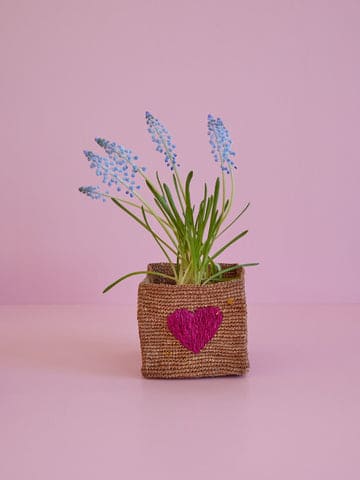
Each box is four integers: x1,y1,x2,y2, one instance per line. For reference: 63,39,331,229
137,263,249,378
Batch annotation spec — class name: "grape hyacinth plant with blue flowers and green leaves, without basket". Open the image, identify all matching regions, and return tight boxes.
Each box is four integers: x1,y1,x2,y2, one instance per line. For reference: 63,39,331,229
79,112,257,293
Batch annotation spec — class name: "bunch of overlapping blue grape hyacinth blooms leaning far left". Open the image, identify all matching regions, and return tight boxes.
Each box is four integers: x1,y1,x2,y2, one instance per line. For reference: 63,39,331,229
80,138,145,198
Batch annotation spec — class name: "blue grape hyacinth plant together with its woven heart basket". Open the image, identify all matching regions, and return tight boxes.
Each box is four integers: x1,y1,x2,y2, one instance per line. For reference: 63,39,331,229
79,112,257,378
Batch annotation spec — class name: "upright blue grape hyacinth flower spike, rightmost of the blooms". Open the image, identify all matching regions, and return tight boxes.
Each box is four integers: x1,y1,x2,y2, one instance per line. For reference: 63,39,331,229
208,114,237,173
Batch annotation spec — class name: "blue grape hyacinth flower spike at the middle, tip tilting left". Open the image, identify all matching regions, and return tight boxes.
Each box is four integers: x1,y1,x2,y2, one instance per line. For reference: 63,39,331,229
145,112,180,170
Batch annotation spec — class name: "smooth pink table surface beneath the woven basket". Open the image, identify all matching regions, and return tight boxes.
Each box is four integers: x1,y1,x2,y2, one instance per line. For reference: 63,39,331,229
0,305,360,480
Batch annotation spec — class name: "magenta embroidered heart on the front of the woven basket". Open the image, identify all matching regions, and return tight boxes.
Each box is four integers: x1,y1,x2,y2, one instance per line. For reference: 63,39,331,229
167,307,223,353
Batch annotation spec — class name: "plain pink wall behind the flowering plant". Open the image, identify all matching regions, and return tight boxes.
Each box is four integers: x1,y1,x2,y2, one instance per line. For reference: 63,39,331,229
0,0,360,303
